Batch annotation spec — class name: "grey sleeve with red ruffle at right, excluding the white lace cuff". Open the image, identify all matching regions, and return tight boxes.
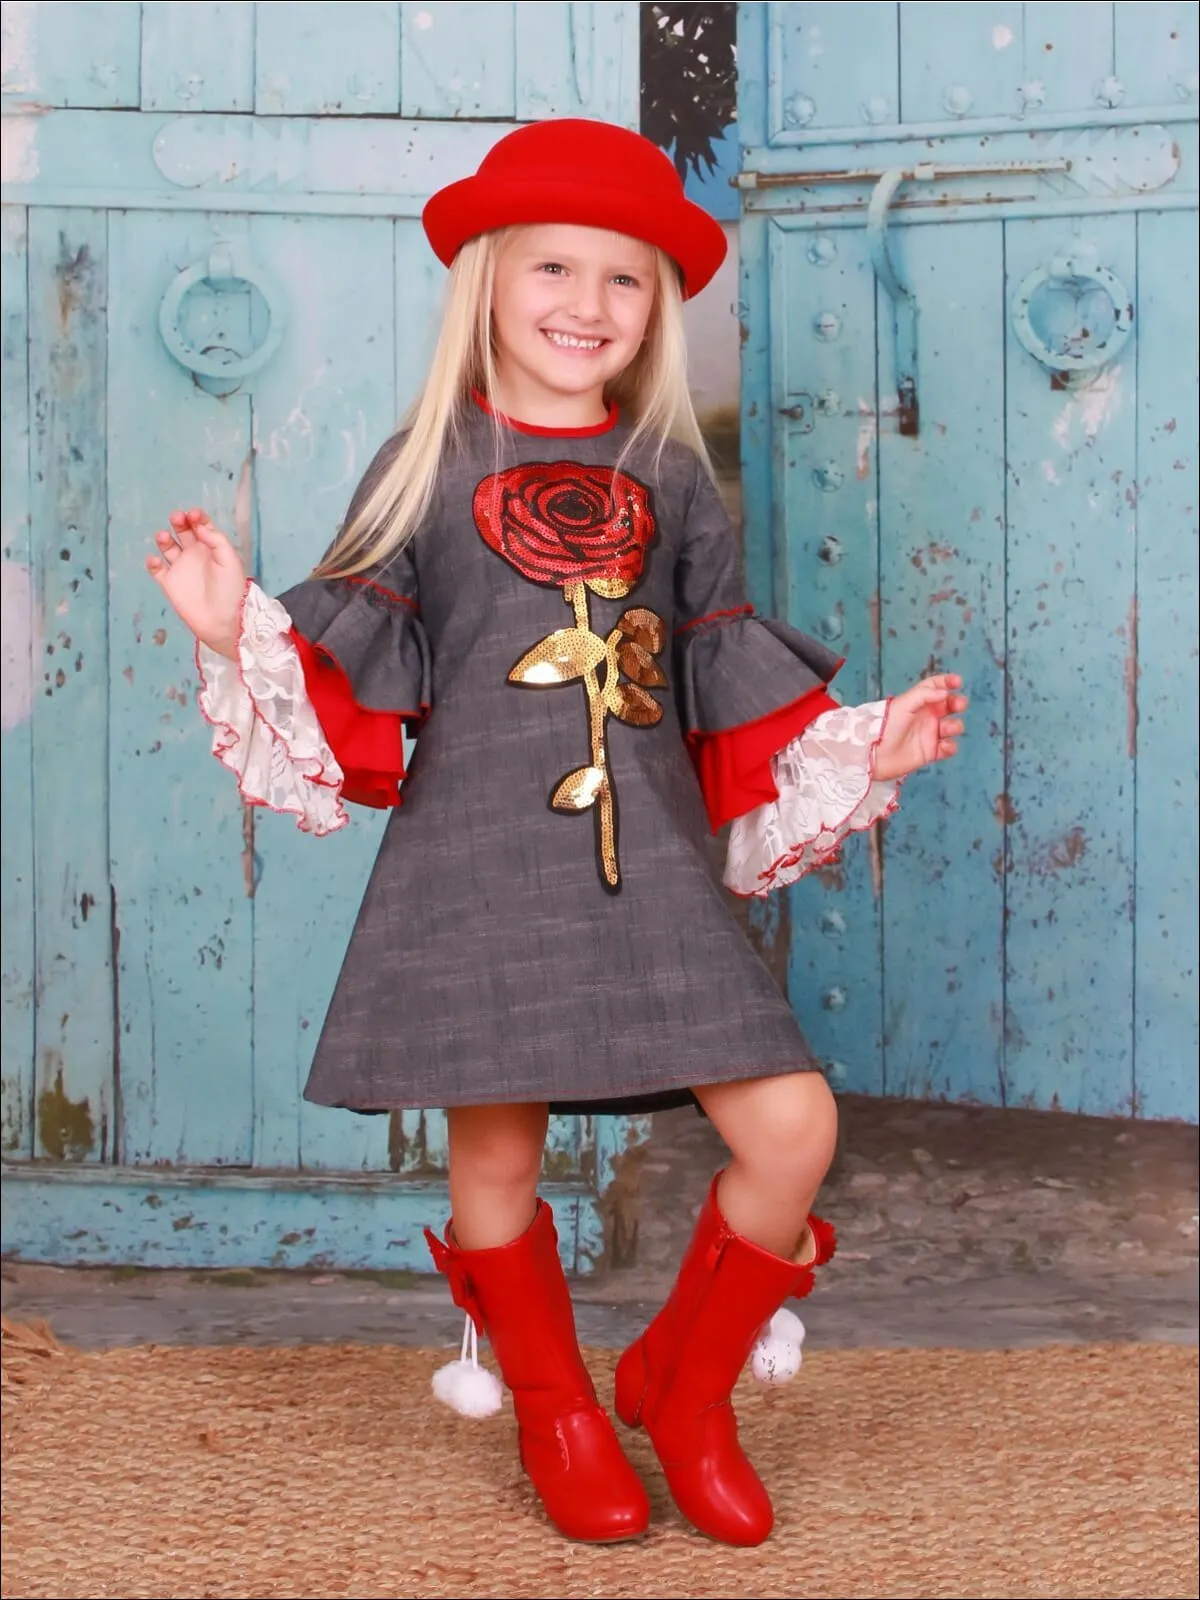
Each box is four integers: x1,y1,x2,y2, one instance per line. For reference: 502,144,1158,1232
675,462,842,834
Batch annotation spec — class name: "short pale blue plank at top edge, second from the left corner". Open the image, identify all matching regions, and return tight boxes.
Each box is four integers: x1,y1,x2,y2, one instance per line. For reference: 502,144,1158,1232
141,0,254,112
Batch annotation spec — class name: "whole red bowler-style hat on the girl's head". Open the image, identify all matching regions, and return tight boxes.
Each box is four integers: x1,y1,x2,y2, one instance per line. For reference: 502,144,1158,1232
421,117,725,299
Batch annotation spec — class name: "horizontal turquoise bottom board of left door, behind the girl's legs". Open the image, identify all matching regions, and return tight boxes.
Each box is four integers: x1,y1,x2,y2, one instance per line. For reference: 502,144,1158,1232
0,1163,595,1273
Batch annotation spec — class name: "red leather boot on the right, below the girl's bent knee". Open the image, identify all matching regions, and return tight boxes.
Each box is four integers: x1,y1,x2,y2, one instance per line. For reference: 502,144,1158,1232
616,1174,835,1544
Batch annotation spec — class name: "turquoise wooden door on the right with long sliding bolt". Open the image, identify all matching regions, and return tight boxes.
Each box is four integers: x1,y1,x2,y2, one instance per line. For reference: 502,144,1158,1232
739,0,1198,1120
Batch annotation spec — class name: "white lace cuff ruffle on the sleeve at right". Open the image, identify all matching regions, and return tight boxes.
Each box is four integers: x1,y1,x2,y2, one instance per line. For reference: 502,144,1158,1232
725,701,899,896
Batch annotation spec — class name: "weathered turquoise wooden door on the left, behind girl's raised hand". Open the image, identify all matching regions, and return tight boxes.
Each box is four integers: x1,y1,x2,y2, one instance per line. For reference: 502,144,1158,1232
3,3,645,1270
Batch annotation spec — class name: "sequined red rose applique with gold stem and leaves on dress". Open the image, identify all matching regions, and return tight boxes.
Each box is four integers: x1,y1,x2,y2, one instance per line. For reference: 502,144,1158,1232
474,461,667,894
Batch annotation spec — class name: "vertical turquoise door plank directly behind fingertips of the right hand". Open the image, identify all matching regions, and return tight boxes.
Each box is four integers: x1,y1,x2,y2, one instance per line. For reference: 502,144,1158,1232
876,222,1008,1101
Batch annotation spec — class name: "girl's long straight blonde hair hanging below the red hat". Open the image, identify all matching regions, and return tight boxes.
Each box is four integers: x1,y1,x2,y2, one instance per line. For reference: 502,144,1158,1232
312,227,712,578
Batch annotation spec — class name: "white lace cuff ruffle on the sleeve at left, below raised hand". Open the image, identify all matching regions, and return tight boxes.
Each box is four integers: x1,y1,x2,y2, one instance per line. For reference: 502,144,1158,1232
195,584,349,837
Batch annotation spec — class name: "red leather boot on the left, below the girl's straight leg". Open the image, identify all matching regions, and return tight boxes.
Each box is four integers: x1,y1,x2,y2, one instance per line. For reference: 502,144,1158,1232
426,1200,650,1542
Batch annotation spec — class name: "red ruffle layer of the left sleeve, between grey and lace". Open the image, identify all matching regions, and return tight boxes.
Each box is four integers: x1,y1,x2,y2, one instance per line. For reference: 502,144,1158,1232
291,627,429,810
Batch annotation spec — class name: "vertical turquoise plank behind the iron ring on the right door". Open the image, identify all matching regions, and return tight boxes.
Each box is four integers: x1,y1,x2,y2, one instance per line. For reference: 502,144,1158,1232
1003,218,1138,1115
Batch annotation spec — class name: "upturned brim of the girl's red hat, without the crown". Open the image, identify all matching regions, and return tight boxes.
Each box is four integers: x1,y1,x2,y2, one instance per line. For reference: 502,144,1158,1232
421,173,728,299
